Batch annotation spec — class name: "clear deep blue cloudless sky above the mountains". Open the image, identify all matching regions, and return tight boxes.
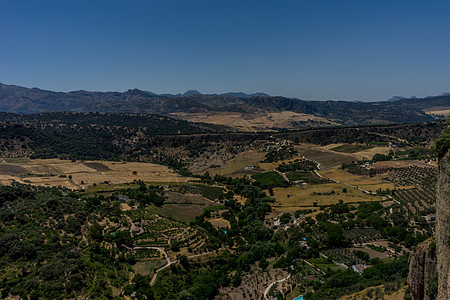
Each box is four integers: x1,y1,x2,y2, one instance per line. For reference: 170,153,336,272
0,0,450,100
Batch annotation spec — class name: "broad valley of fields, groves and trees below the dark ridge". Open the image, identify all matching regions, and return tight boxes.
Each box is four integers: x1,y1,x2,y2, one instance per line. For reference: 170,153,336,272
0,114,443,299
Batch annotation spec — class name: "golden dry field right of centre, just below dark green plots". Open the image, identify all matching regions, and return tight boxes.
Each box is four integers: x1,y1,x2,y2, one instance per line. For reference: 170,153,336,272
273,183,382,211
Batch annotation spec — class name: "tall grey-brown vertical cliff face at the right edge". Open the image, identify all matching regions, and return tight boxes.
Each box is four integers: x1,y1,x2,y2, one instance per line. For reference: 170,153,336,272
436,157,450,300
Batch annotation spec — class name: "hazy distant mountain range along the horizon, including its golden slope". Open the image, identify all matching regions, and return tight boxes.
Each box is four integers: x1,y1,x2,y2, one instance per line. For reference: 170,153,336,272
0,84,450,130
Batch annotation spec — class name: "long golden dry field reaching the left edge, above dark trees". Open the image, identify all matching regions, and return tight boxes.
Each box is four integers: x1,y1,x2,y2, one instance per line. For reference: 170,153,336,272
0,158,192,189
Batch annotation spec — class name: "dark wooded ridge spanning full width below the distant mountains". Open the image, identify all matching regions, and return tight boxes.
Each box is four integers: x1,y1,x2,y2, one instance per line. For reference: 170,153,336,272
0,113,445,162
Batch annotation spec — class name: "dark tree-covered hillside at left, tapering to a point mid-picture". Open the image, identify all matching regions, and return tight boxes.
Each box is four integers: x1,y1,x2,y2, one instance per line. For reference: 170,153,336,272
0,112,227,160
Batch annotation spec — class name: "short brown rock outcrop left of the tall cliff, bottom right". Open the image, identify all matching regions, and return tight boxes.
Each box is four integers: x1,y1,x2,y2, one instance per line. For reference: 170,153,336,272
408,239,437,300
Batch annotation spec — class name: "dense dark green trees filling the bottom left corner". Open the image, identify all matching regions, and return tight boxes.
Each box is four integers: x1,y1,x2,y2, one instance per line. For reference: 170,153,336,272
0,184,133,299
